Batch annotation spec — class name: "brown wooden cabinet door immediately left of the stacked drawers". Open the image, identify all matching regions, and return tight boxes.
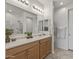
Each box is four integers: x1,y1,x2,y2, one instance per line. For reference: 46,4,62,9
28,45,39,59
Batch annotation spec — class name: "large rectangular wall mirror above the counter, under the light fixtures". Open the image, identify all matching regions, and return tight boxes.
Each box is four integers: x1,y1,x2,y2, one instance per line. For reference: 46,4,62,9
5,3,37,34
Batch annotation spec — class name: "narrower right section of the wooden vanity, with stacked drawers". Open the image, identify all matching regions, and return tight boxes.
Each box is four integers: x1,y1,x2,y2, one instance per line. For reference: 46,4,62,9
40,38,51,59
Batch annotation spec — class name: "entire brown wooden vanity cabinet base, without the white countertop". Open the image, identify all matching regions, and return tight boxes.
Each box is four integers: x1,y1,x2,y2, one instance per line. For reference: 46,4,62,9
6,37,52,59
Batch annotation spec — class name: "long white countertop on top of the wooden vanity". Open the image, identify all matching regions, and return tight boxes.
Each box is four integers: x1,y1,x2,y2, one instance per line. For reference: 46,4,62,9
6,35,50,49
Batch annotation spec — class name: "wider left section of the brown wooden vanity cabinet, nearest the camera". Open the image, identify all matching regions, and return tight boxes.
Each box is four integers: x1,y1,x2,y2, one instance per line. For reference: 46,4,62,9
6,41,39,59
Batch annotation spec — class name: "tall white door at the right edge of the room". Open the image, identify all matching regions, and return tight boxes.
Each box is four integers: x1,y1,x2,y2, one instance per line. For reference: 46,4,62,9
68,9,73,50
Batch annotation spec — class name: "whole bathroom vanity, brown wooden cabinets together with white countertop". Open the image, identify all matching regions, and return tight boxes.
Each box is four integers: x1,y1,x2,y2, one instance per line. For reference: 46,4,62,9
6,35,52,59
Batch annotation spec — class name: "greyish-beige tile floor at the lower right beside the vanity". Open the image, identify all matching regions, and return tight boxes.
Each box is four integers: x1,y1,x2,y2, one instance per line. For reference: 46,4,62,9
45,49,73,59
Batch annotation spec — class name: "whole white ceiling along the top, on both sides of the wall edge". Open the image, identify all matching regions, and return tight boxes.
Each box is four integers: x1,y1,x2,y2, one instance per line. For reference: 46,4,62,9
38,0,73,8
